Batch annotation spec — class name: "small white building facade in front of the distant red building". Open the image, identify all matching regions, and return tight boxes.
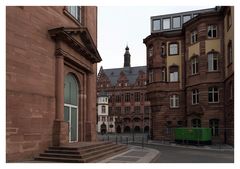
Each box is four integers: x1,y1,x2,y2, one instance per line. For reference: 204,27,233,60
97,92,115,134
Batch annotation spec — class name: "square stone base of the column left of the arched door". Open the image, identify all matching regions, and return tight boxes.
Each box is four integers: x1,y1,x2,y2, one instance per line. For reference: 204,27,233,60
52,120,69,146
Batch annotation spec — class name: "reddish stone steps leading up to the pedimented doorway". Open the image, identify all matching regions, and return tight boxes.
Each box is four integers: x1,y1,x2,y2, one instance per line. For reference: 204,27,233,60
35,142,128,163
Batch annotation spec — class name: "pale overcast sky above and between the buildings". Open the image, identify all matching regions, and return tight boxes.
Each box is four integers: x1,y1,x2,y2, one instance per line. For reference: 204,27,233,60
98,6,215,70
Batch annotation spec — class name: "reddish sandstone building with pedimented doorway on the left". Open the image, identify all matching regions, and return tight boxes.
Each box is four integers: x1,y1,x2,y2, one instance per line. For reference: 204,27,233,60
6,6,101,162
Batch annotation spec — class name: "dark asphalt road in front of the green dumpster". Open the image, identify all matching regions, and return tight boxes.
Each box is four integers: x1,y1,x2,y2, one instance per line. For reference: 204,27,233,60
142,145,234,163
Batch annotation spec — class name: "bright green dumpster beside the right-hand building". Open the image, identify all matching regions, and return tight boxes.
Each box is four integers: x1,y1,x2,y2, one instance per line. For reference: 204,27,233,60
174,128,212,144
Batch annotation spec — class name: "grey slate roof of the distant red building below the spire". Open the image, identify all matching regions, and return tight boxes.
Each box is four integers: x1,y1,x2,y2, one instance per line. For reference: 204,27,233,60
102,66,147,85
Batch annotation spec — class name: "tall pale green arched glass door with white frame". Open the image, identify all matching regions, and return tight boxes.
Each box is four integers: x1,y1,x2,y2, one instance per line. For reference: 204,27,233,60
64,74,79,142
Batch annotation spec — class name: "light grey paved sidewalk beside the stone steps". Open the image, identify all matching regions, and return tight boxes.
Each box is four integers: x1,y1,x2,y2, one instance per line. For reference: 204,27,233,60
98,145,160,163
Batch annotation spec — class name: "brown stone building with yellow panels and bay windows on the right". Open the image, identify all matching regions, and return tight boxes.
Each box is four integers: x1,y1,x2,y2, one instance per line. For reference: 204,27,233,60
144,7,234,144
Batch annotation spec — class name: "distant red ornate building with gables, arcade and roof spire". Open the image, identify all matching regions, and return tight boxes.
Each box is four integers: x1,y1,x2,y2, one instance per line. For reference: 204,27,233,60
97,47,151,133
